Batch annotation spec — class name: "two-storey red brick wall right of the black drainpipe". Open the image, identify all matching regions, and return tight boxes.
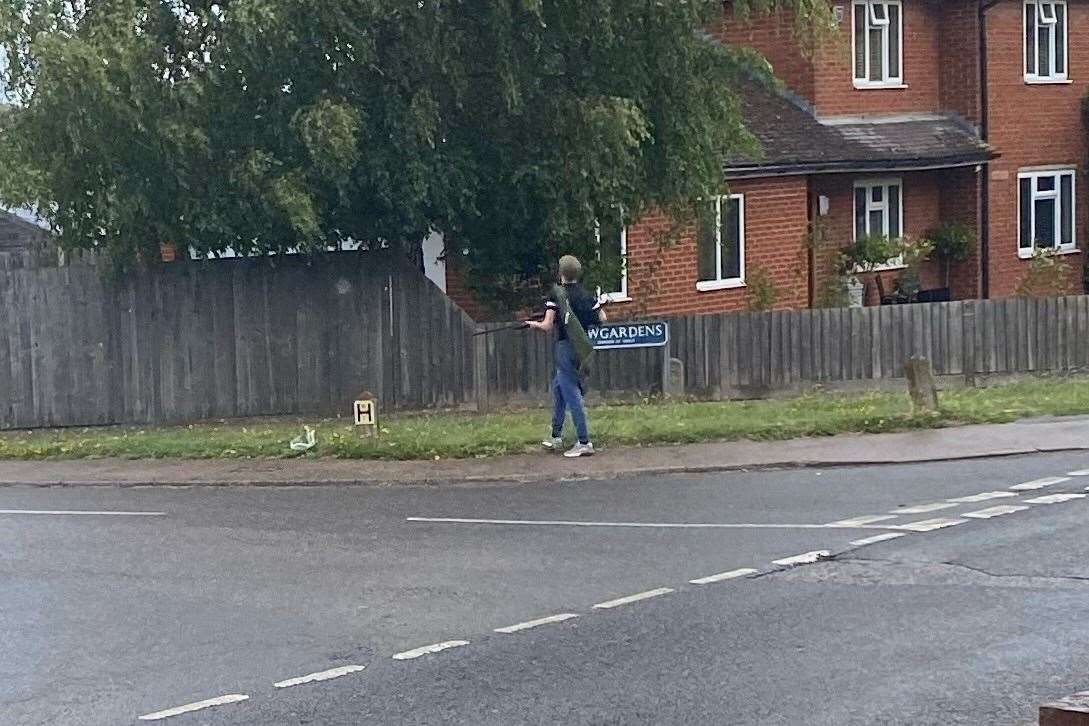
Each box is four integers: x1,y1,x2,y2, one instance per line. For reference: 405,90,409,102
987,0,1089,297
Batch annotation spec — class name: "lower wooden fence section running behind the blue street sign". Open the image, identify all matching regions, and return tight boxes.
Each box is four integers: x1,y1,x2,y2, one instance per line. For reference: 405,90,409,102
478,296,1089,404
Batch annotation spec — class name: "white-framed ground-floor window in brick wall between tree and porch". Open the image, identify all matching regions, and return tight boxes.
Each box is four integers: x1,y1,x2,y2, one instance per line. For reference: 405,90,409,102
696,194,745,291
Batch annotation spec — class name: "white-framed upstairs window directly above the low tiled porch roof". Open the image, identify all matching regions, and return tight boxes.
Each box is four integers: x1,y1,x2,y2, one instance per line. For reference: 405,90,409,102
853,0,904,88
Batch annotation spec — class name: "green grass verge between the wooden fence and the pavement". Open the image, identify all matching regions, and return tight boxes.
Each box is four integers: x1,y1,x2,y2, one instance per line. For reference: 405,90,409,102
0,378,1089,459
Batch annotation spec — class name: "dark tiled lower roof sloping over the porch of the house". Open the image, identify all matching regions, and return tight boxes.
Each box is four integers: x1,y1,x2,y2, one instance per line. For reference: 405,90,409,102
725,79,998,176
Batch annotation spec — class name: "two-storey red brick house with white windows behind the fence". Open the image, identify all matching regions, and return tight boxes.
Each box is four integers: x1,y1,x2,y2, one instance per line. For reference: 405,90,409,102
449,0,1089,316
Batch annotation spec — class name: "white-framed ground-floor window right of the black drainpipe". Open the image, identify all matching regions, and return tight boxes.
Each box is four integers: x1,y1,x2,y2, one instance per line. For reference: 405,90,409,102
1017,170,1076,257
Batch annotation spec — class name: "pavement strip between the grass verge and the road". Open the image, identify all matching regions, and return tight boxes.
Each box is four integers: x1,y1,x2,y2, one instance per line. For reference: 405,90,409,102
6,416,1089,487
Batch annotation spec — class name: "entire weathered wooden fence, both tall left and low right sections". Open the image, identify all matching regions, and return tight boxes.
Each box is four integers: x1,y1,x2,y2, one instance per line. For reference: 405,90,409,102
0,250,1089,429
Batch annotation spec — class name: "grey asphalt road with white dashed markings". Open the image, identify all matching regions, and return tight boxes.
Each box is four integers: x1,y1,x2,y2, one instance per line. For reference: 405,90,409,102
6,454,1089,726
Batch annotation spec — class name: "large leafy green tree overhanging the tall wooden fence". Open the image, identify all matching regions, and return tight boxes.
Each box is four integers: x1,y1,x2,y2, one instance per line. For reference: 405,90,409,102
0,0,830,313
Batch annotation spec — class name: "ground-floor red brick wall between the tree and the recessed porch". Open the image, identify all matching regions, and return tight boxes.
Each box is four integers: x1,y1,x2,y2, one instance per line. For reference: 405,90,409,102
609,176,808,317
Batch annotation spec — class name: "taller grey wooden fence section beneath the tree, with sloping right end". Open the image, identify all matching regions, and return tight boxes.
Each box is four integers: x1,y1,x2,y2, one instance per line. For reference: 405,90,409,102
0,250,475,428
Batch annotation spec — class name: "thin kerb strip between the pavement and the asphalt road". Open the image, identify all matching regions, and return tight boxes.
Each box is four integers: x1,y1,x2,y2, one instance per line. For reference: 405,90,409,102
6,442,1089,489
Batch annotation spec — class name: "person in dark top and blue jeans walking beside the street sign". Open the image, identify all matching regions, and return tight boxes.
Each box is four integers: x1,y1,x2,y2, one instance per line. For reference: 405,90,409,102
526,255,605,458
